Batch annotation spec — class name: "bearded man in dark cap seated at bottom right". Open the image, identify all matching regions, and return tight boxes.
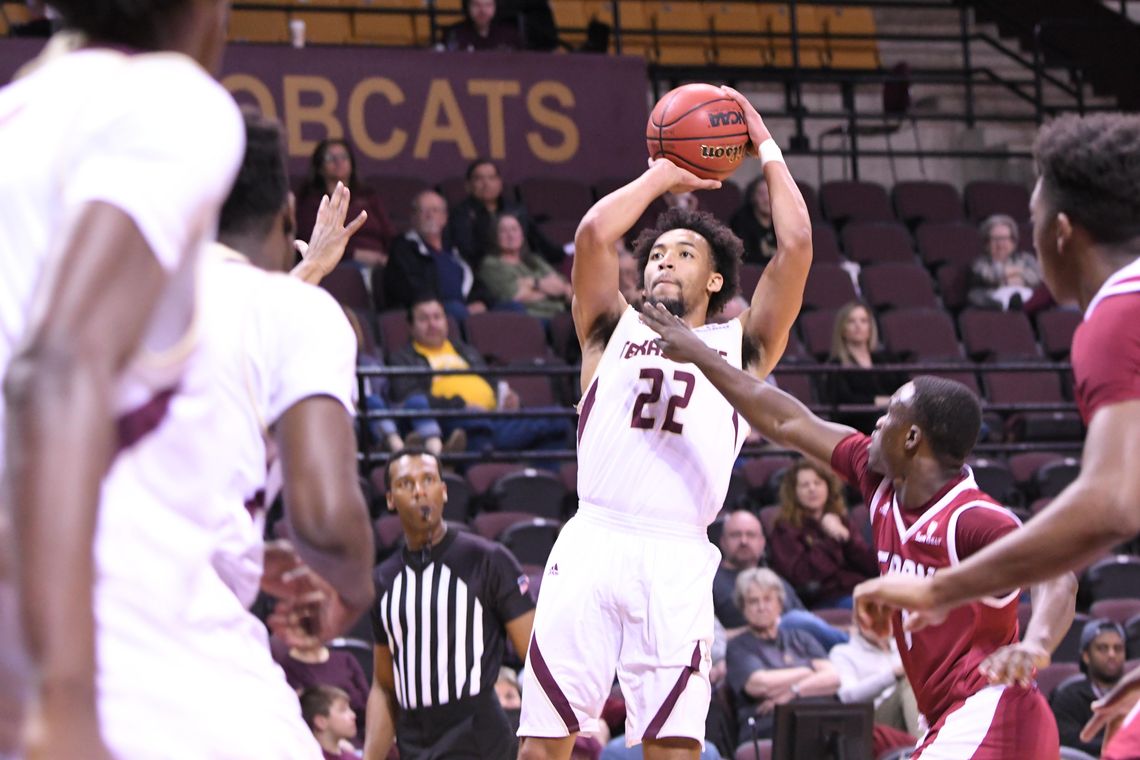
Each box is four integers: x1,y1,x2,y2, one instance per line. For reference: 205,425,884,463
1049,619,1125,758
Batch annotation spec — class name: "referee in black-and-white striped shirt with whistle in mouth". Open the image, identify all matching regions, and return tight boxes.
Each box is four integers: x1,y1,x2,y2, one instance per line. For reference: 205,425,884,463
364,448,535,760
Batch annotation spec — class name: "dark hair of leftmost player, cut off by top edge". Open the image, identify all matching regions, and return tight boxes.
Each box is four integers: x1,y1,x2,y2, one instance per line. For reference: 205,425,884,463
51,0,190,50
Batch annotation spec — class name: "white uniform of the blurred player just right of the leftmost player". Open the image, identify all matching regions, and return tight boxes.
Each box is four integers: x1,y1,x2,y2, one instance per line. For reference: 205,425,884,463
96,245,356,760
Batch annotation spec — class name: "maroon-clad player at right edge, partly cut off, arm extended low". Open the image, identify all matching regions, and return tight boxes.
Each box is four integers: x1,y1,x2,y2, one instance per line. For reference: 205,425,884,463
862,114,1140,760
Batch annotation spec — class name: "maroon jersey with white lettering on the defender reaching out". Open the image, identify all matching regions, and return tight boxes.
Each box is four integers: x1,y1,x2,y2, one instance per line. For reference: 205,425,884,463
831,433,1019,726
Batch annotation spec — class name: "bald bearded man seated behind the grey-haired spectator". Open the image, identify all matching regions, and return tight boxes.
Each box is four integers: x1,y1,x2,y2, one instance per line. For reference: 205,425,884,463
713,509,847,649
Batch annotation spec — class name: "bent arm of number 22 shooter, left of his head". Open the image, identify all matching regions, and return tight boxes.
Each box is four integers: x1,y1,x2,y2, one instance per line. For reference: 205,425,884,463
570,164,720,348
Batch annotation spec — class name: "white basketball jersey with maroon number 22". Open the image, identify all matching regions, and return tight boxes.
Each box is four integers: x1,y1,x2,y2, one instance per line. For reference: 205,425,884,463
578,307,749,528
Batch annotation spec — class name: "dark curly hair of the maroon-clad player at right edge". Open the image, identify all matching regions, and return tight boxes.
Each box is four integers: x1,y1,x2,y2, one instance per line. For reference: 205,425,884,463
1033,114,1140,243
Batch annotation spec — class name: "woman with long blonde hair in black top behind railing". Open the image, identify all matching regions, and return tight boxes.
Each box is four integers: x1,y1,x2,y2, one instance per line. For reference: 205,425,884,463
821,301,906,434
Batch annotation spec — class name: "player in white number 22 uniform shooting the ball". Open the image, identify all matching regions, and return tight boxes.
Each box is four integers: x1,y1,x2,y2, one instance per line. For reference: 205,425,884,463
519,88,812,760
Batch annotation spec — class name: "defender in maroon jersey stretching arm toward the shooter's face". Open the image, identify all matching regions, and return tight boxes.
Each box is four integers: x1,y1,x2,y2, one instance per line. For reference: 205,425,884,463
643,305,1076,760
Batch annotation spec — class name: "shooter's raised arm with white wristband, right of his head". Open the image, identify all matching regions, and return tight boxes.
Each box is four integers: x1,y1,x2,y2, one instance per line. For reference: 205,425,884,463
722,87,812,377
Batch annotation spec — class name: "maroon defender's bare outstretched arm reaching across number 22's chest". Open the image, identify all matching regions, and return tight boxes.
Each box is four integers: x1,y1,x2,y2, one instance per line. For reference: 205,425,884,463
642,304,855,461
